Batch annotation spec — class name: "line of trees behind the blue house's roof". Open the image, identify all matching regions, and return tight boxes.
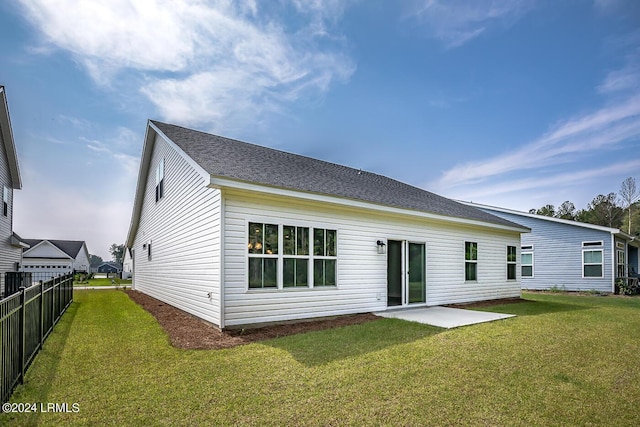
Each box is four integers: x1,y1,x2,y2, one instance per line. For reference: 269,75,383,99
529,177,640,236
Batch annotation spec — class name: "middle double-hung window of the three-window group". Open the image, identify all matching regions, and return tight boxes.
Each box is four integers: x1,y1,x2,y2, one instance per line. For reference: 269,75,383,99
282,225,309,288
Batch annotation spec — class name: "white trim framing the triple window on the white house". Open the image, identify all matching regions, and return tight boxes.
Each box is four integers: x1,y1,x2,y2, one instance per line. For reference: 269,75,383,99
243,221,340,293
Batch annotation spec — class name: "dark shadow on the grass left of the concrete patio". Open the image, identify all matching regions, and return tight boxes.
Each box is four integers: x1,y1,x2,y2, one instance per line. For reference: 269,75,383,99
260,318,446,367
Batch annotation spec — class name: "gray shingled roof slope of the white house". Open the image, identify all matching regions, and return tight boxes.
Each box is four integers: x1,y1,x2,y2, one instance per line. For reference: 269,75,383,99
152,121,523,228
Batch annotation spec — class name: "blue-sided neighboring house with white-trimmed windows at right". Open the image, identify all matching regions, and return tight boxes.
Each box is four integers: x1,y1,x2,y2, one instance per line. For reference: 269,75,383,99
467,203,640,292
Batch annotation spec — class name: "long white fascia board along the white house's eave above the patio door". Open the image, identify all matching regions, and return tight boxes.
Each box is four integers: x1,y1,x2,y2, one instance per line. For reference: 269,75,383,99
210,175,531,233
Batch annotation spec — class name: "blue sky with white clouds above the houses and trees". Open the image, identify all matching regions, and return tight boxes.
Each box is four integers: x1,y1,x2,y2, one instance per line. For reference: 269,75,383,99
0,0,640,258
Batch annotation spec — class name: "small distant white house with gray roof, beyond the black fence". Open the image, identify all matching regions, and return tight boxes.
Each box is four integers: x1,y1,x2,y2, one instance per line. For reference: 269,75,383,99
20,239,90,280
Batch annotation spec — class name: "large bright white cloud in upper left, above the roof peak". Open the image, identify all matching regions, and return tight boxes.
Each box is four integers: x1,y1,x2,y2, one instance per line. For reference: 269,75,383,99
20,0,355,128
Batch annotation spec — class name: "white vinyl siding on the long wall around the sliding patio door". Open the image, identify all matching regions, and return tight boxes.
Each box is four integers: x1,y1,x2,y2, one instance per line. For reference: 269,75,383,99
222,189,520,326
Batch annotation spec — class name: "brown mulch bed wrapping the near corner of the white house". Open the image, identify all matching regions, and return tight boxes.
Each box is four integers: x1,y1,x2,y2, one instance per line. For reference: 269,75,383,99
126,290,379,350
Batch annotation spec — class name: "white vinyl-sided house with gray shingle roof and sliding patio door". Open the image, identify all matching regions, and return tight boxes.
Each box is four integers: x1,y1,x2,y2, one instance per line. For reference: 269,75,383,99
126,121,529,328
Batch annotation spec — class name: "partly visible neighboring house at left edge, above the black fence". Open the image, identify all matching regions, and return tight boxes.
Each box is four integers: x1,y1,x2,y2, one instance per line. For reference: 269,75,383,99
0,86,29,295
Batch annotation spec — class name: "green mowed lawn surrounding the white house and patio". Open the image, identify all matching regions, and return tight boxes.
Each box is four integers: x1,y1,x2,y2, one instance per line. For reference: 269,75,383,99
0,290,640,426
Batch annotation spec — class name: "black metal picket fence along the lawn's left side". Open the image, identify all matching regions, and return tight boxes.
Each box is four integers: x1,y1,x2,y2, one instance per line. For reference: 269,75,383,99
0,273,73,403
